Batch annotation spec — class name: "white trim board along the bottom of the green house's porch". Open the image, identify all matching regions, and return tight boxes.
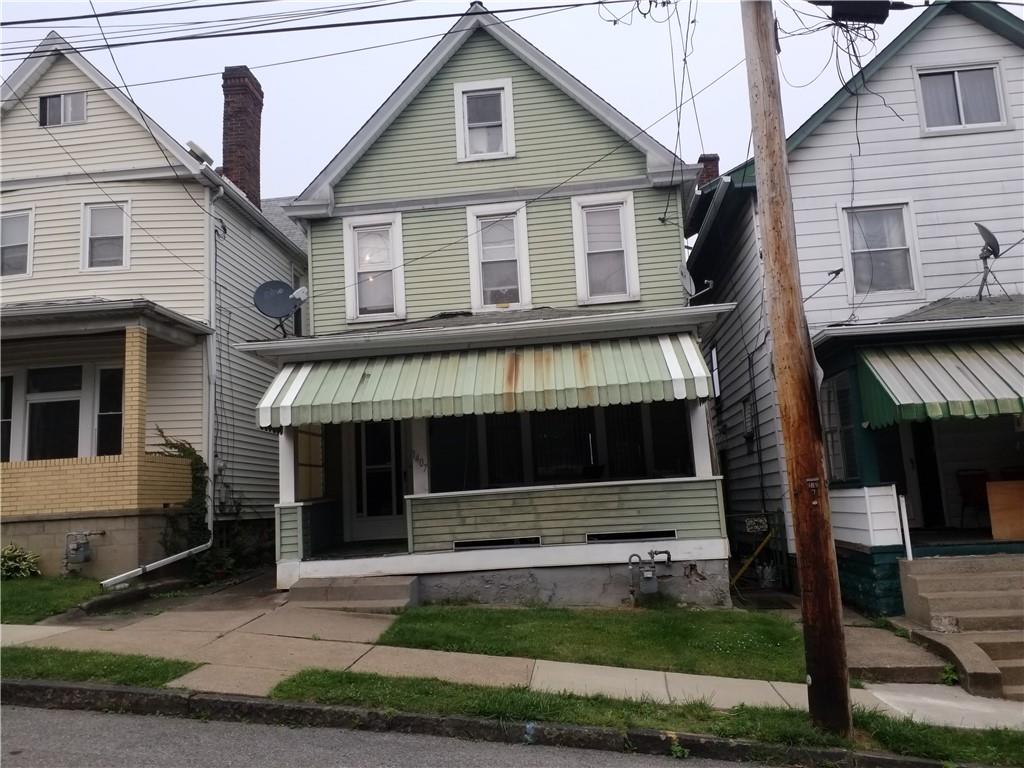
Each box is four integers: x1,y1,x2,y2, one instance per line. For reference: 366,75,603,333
278,539,729,589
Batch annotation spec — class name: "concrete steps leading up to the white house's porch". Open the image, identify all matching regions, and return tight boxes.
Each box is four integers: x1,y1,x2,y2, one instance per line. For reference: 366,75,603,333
900,554,1024,700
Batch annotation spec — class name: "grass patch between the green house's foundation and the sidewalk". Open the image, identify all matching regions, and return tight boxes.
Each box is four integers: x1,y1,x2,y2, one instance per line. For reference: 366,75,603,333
378,605,805,683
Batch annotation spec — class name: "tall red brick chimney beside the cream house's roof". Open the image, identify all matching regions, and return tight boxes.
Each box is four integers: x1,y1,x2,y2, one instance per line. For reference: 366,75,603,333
221,67,263,208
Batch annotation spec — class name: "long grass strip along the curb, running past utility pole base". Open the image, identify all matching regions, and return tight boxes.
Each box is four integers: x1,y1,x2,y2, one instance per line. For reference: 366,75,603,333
270,670,1024,766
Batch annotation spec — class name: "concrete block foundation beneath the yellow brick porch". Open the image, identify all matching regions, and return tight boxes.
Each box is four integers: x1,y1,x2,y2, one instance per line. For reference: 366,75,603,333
0,509,180,579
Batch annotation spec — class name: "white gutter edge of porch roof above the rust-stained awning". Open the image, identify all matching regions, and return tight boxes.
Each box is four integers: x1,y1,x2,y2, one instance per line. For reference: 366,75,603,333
234,303,736,362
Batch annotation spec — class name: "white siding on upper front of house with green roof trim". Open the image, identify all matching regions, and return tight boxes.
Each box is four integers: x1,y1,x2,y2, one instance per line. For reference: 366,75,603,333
790,10,1024,327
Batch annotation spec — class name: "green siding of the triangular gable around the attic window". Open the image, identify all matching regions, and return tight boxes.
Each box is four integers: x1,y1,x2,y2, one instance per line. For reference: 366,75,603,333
335,31,646,204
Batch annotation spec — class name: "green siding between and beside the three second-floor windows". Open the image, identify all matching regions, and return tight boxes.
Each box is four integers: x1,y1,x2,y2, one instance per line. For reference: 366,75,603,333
312,187,683,335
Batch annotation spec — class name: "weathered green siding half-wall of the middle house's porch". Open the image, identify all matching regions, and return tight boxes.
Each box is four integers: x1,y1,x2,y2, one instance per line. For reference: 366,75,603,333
408,479,725,552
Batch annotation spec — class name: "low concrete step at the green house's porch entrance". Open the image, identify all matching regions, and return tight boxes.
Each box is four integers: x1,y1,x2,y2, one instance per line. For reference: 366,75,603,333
288,575,420,613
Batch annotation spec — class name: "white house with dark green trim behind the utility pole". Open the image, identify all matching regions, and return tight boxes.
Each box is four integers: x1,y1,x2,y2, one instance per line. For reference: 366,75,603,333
686,2,1024,613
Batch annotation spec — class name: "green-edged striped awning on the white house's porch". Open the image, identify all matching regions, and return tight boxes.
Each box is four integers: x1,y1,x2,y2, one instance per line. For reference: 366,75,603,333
859,339,1024,427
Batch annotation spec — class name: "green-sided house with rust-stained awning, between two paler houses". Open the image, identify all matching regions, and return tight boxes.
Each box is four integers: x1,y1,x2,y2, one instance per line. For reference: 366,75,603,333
244,3,731,604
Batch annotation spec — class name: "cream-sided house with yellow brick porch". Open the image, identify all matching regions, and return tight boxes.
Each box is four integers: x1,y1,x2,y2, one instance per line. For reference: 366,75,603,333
0,33,306,577
